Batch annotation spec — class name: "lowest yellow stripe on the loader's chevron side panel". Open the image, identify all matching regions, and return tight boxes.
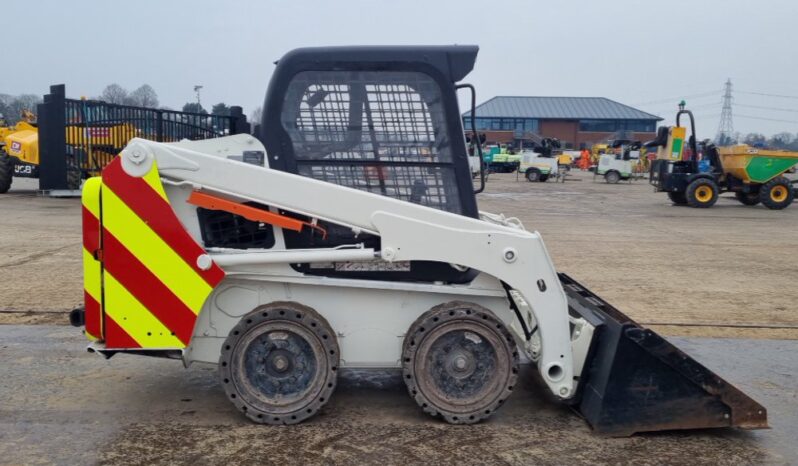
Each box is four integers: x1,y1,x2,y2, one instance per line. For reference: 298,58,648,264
104,271,185,348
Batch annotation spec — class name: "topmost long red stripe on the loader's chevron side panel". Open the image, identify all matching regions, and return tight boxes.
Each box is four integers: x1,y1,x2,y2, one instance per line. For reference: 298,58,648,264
103,157,224,287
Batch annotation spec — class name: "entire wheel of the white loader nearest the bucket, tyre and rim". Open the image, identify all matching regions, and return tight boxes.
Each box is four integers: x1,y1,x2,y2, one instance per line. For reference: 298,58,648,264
402,301,518,424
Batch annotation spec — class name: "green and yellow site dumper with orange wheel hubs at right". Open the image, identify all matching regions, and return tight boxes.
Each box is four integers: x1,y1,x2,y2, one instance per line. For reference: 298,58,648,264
646,102,798,210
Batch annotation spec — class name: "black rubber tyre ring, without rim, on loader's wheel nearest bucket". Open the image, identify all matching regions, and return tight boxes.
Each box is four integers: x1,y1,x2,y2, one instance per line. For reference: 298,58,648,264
402,301,519,424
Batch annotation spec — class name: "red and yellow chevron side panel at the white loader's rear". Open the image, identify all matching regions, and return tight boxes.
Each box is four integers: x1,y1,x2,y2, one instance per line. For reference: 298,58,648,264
84,159,224,349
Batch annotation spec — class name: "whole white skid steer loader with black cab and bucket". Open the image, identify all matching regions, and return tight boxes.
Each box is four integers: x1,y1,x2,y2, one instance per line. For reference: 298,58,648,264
72,46,767,435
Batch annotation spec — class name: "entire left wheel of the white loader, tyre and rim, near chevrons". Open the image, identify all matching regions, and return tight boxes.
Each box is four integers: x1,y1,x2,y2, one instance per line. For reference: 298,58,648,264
219,302,339,424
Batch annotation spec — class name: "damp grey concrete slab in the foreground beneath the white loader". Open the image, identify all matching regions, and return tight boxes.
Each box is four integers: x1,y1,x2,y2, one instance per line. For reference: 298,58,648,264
0,325,798,465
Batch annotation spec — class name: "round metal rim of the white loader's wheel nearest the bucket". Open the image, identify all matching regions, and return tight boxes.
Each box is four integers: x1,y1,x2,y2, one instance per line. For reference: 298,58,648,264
415,320,511,421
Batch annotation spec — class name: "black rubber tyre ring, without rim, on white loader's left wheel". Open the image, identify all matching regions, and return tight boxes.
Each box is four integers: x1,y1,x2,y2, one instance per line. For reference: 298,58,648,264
219,301,340,425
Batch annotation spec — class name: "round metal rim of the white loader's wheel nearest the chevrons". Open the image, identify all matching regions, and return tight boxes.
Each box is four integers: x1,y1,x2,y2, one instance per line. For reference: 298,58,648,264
232,321,328,414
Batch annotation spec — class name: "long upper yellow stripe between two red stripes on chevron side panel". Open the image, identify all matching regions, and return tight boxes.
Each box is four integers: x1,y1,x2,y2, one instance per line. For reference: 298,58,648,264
103,186,213,314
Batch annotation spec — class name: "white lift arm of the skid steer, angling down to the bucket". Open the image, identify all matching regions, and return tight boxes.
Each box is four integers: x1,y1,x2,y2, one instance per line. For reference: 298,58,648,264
120,135,581,398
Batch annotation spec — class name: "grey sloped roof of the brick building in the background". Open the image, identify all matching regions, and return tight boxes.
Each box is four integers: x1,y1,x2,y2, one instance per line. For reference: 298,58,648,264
463,96,662,121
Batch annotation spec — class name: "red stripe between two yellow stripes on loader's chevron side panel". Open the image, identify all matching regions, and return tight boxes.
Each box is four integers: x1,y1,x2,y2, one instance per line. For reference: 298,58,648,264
103,229,197,345
